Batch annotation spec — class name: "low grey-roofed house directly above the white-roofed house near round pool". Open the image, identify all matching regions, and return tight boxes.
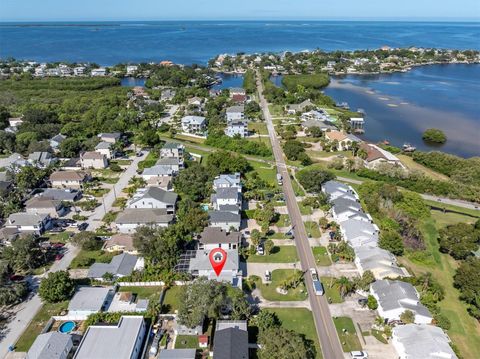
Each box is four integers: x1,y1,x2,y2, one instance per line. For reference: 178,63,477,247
87,253,144,281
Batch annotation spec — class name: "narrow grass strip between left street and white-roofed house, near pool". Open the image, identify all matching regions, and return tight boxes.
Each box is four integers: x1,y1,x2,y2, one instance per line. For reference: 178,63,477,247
15,301,68,352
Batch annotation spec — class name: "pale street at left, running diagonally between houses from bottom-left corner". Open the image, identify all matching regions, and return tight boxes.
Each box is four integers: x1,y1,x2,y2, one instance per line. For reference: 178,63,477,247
0,152,148,358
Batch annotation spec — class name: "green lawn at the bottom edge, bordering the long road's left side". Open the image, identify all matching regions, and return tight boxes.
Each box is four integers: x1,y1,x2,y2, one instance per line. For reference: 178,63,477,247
265,308,322,358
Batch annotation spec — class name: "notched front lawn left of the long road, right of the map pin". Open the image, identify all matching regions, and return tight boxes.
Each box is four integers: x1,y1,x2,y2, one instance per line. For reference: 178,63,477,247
251,269,307,301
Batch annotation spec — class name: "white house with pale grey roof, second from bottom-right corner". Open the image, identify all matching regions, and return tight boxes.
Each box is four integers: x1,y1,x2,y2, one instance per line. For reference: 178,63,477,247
370,279,432,324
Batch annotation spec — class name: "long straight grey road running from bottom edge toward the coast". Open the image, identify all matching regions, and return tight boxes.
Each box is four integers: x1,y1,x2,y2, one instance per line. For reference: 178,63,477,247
257,74,344,359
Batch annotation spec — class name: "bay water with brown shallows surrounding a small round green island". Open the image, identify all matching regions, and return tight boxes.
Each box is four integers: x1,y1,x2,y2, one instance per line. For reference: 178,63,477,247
325,64,480,157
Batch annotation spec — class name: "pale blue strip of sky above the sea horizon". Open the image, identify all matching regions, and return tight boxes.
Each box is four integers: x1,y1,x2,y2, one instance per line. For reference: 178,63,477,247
0,0,480,21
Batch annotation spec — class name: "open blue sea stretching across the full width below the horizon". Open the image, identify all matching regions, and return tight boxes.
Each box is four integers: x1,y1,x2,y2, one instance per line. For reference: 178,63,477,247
0,21,480,65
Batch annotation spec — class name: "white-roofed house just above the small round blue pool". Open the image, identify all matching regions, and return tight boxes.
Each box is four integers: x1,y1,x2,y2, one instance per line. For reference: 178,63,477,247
68,286,113,320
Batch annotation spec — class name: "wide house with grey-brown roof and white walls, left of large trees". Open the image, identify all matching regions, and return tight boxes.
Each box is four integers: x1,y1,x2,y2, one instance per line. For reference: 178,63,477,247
115,208,174,233
